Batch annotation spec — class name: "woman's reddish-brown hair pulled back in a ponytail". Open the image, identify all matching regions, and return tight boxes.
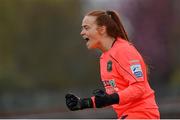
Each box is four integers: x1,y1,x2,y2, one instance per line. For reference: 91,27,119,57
87,10,129,41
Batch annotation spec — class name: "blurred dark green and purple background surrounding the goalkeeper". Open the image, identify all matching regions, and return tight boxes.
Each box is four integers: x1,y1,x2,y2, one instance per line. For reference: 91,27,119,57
0,0,180,118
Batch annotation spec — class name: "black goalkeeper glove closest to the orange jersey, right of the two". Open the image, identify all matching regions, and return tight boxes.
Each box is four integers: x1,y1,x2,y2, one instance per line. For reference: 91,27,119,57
93,89,119,108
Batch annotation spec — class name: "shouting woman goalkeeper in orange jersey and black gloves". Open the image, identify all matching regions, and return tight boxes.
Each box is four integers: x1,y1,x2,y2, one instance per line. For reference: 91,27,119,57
65,11,160,119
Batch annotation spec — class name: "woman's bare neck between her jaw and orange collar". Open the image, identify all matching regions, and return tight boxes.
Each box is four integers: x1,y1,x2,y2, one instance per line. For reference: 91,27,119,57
100,37,115,52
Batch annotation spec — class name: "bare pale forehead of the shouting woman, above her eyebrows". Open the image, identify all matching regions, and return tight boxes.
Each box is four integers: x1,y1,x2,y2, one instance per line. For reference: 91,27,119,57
82,16,96,26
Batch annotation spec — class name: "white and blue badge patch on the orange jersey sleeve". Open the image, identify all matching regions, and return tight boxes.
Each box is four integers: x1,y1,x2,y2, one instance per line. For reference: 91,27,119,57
130,64,143,78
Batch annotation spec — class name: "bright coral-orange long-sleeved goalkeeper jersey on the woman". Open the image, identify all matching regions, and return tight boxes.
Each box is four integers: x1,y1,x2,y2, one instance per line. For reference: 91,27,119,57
100,38,159,118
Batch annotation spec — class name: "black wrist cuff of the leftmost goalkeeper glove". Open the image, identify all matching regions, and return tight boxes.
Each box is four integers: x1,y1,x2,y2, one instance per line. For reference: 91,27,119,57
81,98,93,109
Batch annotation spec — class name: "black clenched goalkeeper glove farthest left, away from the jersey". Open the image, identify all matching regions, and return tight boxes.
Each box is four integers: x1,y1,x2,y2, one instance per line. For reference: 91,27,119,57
65,94,93,111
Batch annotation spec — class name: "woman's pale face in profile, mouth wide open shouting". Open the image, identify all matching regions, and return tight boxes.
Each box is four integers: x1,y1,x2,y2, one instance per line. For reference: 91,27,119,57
80,16,101,49
